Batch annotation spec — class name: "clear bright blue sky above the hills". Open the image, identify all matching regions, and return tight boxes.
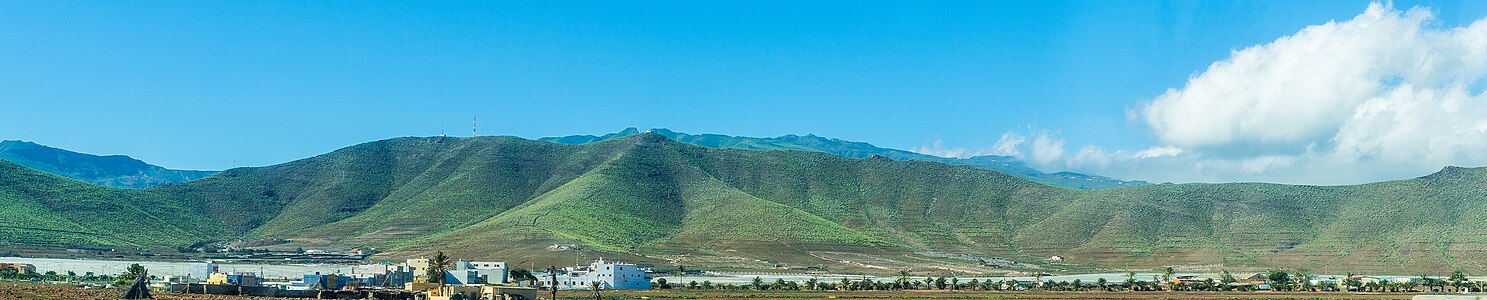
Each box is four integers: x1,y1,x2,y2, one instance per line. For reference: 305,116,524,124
0,1,1487,181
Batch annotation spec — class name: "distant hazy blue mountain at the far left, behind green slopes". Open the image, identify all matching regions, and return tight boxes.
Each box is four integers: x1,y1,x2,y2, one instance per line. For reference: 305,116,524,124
0,141,213,189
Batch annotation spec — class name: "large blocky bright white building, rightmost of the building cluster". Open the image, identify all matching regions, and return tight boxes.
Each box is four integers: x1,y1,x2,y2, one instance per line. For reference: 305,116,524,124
538,260,651,290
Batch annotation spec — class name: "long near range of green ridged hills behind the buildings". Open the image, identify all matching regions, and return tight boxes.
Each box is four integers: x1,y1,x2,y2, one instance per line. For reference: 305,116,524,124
0,132,1487,275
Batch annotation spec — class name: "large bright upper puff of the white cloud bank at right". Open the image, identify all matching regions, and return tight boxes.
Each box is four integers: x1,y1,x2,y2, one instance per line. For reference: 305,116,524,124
1141,3,1468,151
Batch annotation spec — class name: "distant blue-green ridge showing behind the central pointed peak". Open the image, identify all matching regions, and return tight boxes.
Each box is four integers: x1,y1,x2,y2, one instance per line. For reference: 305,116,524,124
540,128,1146,190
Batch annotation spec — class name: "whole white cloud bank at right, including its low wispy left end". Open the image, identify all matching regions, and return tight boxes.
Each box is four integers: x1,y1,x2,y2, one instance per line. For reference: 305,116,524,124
993,3,1487,184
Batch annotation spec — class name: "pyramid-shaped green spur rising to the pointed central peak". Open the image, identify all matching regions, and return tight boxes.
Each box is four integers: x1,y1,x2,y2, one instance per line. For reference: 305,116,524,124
415,137,880,258
